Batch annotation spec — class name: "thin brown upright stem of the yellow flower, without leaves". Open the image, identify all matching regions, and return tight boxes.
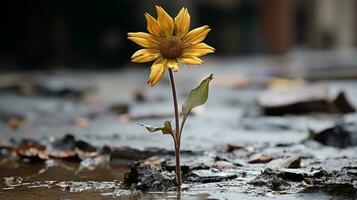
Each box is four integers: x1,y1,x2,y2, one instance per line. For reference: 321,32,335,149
169,69,181,187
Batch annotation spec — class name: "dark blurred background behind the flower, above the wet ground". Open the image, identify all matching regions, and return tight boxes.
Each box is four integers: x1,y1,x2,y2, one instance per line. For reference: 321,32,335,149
0,0,357,71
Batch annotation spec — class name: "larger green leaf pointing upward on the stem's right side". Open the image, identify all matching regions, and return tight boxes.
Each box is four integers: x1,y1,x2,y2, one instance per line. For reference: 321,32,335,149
182,74,213,118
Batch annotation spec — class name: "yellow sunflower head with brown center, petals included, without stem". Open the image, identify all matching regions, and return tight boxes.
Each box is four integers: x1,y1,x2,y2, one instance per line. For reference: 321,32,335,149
128,6,215,86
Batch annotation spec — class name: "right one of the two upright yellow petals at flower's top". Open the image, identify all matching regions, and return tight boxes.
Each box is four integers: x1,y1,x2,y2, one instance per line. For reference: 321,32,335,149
175,8,191,38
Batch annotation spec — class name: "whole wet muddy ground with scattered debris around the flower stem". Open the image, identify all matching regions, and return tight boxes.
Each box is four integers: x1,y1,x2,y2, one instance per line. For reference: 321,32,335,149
0,52,357,200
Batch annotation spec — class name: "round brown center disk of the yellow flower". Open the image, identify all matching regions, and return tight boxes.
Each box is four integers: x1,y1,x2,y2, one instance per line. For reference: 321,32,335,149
159,36,183,59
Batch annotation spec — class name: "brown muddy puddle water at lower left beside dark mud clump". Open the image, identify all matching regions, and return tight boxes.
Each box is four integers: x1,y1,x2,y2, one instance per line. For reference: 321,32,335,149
0,158,127,199
